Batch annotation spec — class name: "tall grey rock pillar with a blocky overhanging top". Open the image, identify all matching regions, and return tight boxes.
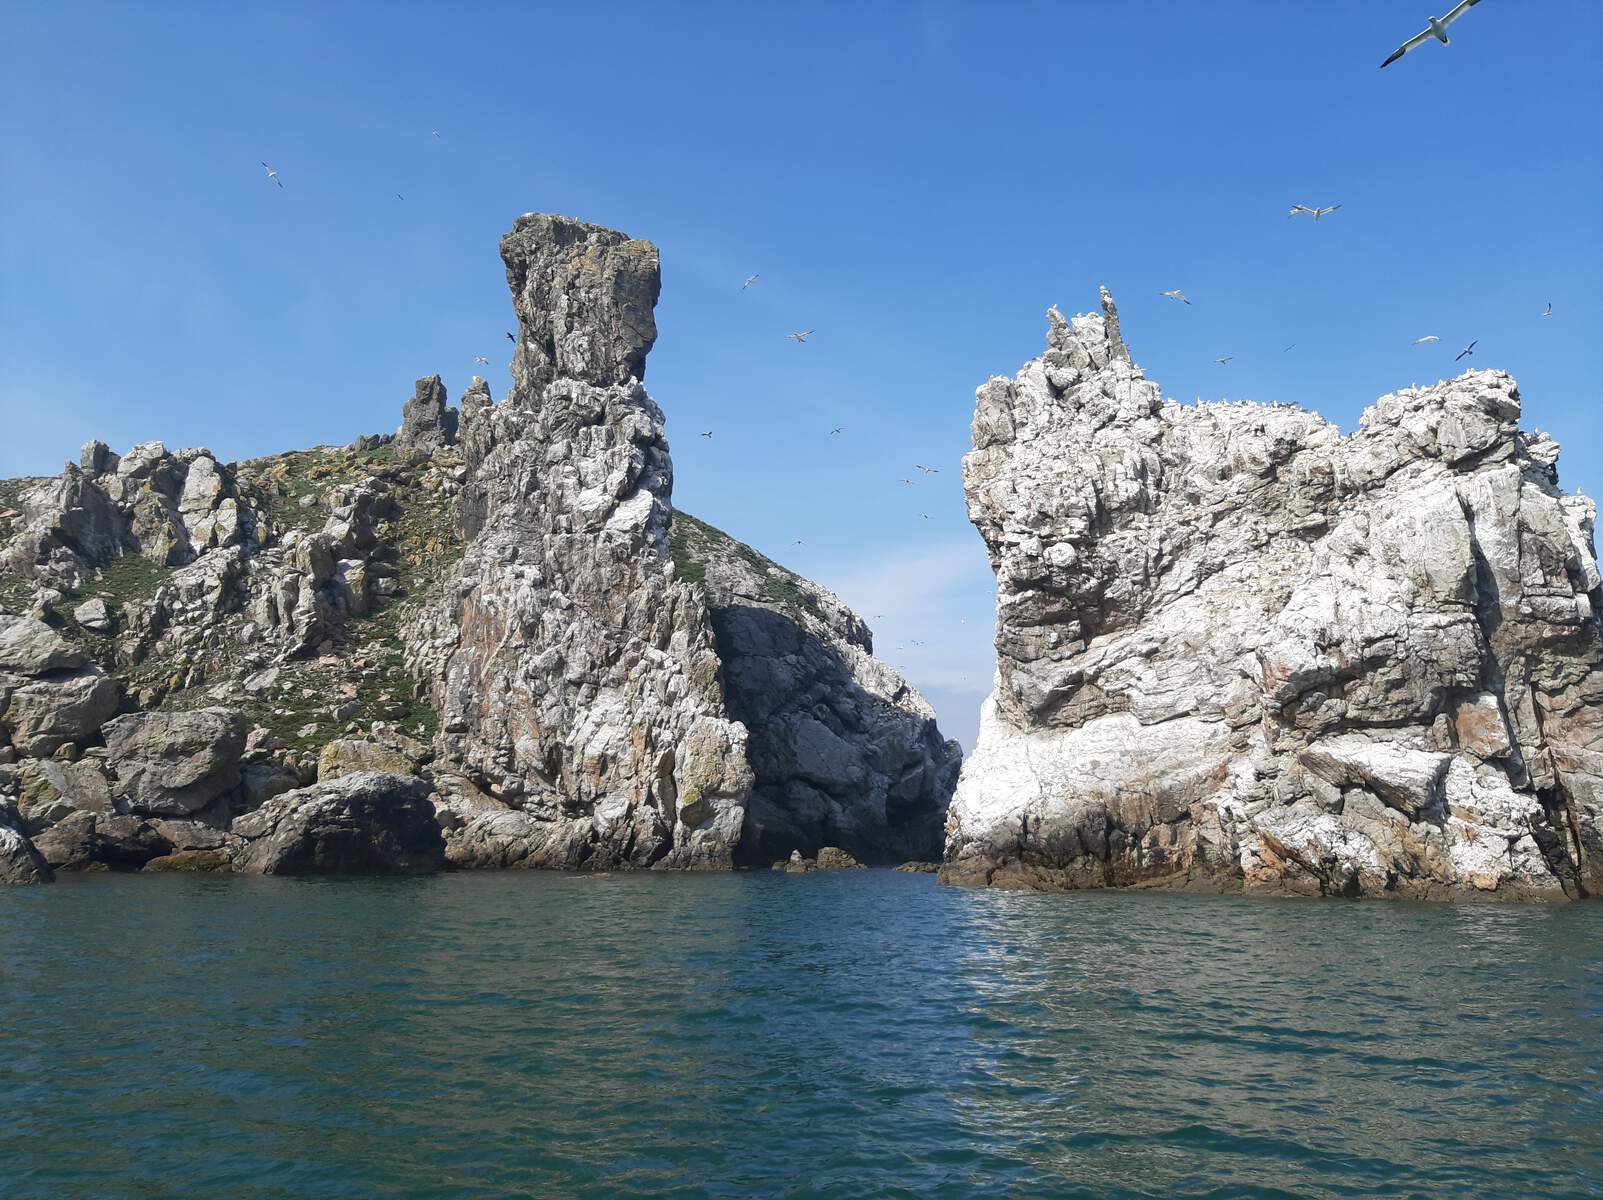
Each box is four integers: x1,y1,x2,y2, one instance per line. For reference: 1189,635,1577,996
409,216,752,867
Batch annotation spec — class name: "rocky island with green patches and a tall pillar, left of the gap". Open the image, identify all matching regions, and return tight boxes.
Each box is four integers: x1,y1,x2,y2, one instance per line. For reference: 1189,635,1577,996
0,215,960,883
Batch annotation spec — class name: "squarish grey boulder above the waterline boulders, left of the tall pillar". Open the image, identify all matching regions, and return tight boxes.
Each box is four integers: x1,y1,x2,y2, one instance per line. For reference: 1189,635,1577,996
103,708,245,815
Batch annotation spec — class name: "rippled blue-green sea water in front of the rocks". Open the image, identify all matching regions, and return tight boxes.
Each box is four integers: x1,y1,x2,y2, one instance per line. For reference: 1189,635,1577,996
0,872,1603,1200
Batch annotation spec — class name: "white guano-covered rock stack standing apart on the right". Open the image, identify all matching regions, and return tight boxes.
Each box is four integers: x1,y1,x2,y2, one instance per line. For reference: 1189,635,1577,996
943,292,1603,899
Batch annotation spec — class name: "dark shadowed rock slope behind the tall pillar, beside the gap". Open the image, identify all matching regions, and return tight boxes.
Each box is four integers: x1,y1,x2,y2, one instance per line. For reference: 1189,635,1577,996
673,513,962,864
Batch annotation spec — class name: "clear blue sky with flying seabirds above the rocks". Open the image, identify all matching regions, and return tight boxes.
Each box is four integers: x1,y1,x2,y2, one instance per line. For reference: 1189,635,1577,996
0,0,1603,743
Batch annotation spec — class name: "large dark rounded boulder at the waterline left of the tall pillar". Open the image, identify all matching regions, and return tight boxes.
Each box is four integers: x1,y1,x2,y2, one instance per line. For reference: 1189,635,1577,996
234,771,446,875
